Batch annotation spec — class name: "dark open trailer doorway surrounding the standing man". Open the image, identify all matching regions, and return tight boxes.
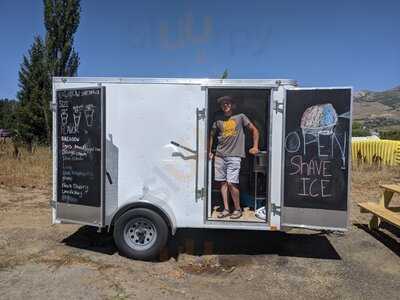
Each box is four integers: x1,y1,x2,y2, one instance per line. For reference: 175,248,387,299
206,88,270,223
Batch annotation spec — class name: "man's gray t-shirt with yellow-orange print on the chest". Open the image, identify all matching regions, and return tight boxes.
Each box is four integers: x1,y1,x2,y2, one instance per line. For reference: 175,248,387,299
212,114,250,157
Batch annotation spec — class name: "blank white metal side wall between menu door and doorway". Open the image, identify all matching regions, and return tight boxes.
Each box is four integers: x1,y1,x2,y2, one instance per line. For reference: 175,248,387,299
104,84,204,227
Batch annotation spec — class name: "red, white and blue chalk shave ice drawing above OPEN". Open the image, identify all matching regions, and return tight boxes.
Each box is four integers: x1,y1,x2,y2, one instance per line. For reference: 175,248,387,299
300,103,338,136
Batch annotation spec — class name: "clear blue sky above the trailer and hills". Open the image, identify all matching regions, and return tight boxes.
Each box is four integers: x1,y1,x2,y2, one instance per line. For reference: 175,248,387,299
0,0,400,98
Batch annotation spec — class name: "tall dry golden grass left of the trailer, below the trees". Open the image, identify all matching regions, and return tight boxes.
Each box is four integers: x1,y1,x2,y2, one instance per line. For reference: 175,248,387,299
0,142,52,188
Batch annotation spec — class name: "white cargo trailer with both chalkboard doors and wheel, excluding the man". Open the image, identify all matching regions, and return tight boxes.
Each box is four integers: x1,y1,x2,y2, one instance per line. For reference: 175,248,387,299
51,77,352,259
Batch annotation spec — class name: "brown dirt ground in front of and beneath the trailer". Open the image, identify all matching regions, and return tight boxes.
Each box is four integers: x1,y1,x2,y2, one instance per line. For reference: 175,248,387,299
0,174,400,299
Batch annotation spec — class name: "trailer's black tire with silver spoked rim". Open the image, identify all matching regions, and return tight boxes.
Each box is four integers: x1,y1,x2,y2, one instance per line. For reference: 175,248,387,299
114,208,169,260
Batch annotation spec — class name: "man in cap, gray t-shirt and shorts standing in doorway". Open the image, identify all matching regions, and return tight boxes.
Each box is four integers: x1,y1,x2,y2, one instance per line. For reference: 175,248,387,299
209,96,259,219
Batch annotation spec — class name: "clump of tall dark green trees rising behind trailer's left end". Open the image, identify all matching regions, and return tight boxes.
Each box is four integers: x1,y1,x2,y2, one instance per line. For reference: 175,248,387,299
16,0,80,147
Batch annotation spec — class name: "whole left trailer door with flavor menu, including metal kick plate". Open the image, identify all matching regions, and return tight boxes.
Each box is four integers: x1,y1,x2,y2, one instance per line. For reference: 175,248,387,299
53,87,105,227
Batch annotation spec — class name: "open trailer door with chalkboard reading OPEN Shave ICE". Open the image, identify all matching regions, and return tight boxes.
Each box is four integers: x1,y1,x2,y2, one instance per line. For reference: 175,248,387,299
281,88,352,230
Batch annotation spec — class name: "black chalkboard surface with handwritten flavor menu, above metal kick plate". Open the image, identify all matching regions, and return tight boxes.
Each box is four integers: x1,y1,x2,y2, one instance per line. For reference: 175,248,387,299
56,88,104,207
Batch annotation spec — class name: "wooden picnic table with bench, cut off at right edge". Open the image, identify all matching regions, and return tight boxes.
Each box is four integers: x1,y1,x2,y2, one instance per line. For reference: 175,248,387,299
357,184,400,230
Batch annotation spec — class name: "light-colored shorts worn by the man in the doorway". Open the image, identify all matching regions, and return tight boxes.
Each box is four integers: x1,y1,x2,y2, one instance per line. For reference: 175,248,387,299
214,156,242,184
